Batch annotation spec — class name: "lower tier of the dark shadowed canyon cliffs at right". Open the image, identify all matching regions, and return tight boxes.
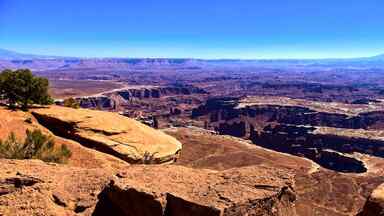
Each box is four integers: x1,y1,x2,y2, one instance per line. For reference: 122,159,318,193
210,121,384,173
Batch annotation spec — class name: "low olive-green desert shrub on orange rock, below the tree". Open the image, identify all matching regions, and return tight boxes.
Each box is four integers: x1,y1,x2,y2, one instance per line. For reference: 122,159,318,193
0,130,72,163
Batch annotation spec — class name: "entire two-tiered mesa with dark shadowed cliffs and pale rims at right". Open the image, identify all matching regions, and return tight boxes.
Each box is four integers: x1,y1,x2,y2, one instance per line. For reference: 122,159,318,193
192,97,384,173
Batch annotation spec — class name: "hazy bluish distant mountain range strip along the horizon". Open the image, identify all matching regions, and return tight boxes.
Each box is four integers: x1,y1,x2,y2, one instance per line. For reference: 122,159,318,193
0,49,384,70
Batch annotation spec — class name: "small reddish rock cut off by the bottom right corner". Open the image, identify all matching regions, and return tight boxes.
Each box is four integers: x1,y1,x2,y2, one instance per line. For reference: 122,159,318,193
357,184,384,216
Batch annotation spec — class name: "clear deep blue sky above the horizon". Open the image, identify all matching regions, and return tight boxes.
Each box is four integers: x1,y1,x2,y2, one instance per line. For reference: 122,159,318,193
0,0,384,59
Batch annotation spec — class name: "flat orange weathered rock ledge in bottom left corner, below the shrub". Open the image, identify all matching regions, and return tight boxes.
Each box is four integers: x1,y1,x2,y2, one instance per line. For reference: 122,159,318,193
0,159,113,216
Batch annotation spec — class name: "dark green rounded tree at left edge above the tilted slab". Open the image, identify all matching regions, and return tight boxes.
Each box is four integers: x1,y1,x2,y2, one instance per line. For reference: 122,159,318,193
0,69,52,110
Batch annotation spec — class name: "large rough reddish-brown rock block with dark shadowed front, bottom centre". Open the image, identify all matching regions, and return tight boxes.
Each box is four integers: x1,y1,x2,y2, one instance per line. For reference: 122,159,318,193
99,166,296,216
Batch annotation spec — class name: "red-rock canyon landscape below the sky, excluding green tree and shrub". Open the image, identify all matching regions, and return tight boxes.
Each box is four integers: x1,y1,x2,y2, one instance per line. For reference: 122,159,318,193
0,54,384,216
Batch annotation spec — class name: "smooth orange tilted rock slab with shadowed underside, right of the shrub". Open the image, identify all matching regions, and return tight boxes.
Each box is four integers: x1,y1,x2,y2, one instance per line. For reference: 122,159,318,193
32,106,182,163
